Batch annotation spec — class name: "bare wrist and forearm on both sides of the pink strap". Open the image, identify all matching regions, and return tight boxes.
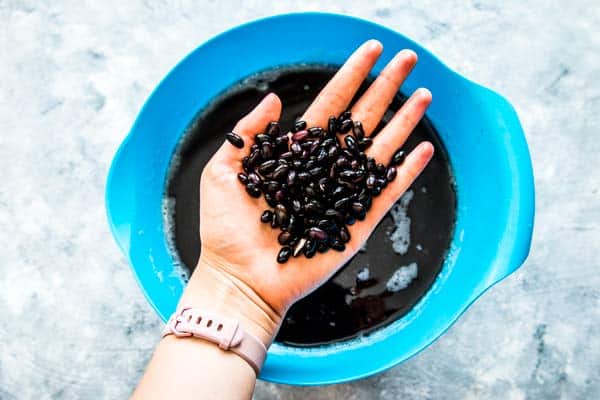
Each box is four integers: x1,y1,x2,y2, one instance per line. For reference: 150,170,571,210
132,261,280,400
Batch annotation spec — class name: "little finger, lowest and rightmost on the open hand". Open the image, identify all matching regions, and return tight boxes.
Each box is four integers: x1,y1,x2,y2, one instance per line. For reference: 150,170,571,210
348,142,434,249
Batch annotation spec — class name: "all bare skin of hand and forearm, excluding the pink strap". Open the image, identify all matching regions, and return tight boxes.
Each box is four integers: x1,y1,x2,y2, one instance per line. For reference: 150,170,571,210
133,40,433,399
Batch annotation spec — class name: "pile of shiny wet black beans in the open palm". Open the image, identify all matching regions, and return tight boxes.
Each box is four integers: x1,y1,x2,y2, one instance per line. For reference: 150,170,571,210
226,111,404,263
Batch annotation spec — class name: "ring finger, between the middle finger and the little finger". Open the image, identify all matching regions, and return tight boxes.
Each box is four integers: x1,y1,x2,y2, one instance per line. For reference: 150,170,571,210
367,88,431,163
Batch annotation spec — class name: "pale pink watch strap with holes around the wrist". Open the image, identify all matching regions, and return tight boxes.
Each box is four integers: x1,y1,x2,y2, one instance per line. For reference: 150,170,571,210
162,307,267,376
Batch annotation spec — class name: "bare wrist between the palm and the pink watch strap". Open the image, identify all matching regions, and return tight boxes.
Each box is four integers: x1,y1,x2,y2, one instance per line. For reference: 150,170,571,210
179,256,282,348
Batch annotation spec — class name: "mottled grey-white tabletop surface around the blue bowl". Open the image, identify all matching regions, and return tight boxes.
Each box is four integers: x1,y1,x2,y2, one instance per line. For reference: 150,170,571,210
0,0,600,400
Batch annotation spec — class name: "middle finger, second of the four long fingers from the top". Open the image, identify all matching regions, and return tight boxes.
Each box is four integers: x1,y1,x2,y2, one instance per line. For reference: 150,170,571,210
352,50,417,136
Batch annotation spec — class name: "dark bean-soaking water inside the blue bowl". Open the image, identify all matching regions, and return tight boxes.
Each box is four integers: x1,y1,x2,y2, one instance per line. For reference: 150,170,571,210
168,66,456,346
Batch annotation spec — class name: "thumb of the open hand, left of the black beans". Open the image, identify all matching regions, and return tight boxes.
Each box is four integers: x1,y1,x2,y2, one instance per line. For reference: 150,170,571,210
218,93,281,160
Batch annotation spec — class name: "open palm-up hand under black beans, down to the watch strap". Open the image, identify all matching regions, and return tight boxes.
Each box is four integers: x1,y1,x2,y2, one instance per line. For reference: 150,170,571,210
181,40,433,344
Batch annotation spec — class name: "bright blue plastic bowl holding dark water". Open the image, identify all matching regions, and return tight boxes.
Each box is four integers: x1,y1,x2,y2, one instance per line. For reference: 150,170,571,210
106,13,534,385
